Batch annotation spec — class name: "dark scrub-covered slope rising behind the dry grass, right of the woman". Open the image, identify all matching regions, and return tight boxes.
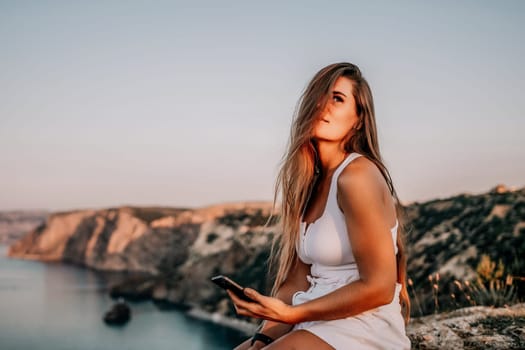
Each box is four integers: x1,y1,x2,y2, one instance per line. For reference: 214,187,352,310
406,186,525,313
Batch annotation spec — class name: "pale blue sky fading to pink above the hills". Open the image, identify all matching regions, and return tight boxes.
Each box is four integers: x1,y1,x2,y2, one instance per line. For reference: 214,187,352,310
0,0,525,210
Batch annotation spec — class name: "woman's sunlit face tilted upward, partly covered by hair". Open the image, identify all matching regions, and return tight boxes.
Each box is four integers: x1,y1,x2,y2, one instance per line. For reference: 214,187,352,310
313,77,359,141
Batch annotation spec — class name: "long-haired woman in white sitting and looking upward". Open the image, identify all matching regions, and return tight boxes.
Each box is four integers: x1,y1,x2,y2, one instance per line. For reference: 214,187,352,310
228,63,410,350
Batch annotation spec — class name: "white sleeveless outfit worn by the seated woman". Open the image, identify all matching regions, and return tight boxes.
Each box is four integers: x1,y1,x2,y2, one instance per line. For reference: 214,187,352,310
292,152,411,350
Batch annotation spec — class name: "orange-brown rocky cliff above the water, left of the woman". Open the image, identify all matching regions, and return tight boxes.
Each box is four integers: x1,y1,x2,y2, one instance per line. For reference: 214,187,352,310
8,202,275,311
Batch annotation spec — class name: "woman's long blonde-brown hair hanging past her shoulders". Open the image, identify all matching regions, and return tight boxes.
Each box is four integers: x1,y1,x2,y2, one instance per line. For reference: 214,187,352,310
269,62,410,324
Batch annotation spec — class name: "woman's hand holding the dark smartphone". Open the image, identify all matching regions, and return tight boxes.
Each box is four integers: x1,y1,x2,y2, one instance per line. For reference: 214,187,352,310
226,288,300,324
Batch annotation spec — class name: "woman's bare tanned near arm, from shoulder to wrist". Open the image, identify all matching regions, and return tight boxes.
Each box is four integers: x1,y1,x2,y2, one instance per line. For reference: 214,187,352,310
294,157,397,321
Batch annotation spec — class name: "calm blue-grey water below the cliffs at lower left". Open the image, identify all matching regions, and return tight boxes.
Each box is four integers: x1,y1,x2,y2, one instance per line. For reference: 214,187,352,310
0,246,245,350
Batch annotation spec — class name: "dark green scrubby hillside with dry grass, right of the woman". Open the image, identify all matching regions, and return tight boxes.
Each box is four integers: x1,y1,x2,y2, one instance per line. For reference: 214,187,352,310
405,188,525,316
